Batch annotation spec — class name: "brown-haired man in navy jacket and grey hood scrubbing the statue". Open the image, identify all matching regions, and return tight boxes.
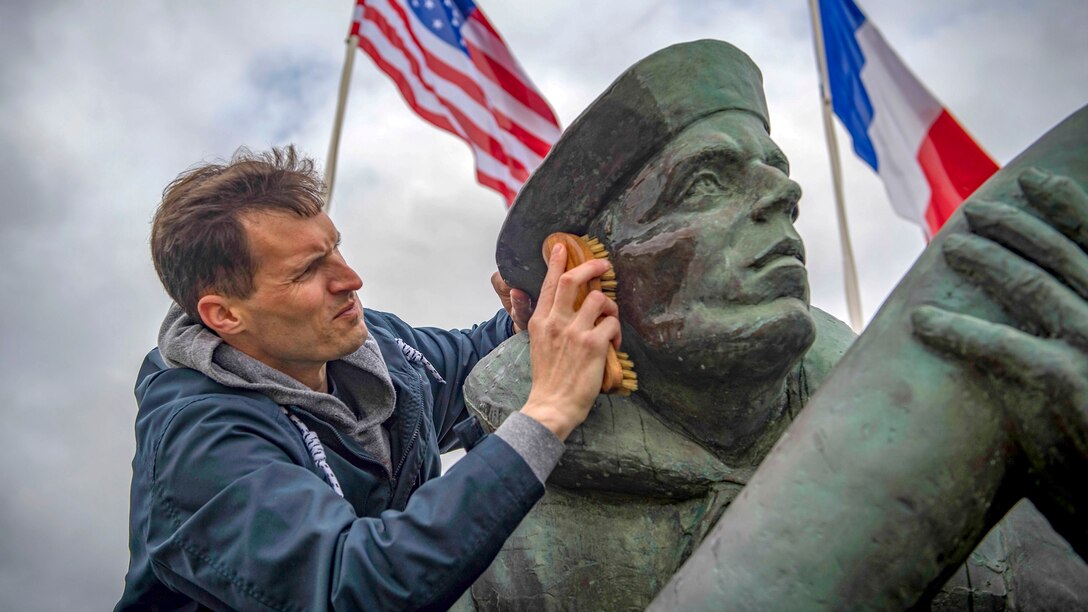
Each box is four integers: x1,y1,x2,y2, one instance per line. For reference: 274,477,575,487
118,147,619,610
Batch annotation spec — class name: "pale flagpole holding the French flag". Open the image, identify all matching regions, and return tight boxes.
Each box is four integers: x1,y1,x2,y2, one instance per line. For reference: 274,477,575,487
808,0,864,333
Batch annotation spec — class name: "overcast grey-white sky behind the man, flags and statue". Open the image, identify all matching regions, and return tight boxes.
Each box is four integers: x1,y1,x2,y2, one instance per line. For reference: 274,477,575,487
0,0,1088,610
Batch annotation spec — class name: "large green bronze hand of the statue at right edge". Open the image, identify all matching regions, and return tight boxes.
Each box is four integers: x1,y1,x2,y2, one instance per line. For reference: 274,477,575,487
913,169,1088,554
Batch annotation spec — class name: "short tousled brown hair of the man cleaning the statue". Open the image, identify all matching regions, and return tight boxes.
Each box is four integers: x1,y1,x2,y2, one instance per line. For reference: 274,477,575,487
151,145,324,321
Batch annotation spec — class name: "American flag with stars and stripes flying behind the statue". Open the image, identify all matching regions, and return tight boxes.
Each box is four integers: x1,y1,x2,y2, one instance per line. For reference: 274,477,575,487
351,0,560,206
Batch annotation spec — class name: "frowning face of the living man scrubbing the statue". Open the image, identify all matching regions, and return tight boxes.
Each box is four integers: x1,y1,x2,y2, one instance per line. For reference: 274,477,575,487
232,212,367,378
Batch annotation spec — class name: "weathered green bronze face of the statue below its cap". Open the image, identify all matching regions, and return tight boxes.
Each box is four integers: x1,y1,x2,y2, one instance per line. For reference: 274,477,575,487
598,111,814,375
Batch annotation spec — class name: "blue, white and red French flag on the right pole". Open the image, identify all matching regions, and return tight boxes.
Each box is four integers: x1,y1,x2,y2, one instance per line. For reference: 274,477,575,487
819,0,998,238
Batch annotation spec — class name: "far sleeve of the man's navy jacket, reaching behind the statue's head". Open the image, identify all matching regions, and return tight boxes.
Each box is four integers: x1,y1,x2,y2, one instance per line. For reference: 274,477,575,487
367,310,514,452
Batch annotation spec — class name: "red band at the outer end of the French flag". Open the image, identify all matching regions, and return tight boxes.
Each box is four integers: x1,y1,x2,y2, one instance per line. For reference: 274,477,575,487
918,110,998,236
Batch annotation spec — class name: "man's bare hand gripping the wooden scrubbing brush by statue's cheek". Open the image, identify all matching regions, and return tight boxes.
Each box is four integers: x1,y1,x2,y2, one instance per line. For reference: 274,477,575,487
521,245,620,440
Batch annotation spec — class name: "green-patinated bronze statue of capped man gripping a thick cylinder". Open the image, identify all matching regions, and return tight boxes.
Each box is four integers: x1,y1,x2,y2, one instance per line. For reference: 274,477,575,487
458,40,1088,610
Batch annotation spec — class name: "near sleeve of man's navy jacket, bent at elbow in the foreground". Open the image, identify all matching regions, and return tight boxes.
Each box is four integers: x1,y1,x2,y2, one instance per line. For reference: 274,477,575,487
146,395,543,610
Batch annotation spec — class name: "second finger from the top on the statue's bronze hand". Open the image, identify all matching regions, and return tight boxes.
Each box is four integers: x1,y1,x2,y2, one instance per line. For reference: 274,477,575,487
963,200,1088,299
